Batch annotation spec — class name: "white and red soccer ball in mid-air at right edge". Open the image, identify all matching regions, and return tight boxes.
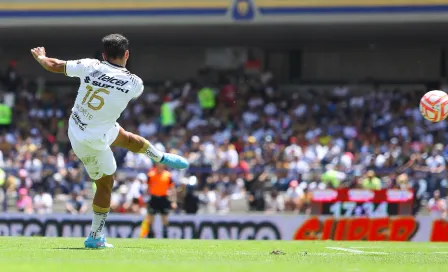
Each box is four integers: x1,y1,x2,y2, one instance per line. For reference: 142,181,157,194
420,91,448,122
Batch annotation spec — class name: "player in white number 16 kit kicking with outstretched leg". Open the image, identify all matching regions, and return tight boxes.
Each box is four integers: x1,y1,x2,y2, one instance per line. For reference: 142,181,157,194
31,34,188,248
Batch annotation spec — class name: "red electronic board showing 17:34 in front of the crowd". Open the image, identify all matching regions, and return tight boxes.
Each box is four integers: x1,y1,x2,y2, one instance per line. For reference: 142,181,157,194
311,188,414,217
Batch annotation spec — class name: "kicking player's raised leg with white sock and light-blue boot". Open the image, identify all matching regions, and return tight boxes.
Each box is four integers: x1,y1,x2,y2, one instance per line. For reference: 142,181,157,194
112,127,188,169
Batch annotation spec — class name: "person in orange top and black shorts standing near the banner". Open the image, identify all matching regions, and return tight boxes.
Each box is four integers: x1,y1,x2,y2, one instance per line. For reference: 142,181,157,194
140,164,176,238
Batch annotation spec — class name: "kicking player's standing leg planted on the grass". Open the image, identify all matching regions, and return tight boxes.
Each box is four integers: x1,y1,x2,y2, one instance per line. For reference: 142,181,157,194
84,175,114,248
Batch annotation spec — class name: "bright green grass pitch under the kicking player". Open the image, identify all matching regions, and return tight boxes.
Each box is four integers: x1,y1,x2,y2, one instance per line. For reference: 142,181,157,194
0,237,448,272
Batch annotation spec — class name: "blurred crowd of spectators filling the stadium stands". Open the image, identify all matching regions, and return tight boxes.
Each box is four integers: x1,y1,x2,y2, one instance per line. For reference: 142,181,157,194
0,59,448,217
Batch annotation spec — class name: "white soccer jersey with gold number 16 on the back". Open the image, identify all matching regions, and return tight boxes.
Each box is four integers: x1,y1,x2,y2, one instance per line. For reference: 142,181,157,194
65,59,144,150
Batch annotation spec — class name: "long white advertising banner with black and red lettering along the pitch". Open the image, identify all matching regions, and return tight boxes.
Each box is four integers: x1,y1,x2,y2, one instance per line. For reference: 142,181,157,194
0,213,448,242
